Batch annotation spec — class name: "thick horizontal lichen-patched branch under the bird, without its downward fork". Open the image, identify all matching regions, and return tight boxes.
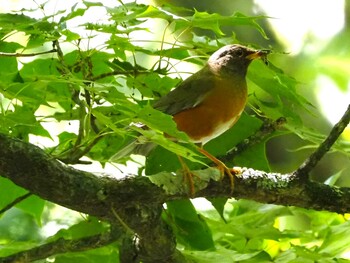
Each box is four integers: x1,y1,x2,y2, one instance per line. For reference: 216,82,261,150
0,134,350,218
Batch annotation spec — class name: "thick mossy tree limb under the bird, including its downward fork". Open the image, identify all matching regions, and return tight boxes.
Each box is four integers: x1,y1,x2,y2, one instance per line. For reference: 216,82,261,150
0,134,350,263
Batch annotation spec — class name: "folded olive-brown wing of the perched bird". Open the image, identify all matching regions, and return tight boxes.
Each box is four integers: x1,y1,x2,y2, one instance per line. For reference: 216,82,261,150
153,68,215,115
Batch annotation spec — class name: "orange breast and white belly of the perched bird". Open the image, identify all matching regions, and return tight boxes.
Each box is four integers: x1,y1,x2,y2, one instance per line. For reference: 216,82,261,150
173,79,247,144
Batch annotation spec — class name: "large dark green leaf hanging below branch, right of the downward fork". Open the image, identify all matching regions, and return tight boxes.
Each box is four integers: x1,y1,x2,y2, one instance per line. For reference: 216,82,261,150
167,200,214,250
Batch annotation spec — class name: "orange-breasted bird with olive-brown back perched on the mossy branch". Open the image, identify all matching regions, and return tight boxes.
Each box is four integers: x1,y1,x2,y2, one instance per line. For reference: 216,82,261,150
113,44,268,194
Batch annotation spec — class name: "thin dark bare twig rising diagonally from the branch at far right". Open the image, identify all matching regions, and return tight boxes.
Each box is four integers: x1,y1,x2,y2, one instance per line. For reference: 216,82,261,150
294,105,350,181
